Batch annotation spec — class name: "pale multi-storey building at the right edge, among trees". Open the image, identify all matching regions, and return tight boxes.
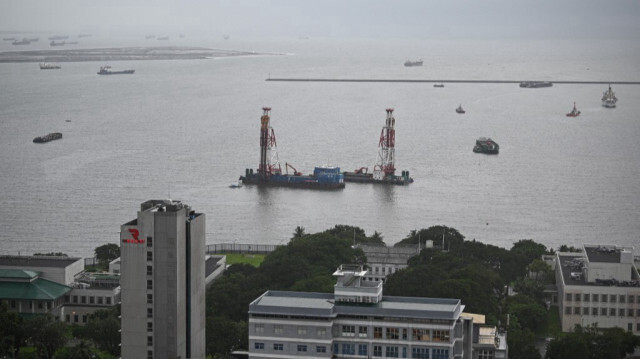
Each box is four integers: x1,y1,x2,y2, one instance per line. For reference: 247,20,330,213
555,245,640,335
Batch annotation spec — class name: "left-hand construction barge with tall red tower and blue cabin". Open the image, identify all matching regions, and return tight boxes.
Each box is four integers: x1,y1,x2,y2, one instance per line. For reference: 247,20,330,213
239,107,345,189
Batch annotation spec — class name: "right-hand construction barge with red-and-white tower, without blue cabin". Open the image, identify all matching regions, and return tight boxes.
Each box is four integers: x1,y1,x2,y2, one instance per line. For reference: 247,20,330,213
343,108,413,185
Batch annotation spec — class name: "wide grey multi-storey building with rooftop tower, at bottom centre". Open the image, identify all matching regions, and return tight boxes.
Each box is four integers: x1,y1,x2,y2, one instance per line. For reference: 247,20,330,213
249,265,507,359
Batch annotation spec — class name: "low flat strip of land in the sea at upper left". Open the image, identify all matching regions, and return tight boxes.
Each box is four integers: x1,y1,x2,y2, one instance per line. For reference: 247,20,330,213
0,46,274,63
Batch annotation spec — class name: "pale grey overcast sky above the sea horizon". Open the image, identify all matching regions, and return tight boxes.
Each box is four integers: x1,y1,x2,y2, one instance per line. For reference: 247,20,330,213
0,0,640,38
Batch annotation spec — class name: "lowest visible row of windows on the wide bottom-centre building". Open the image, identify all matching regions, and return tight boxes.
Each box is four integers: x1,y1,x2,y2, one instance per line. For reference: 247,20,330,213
253,342,450,359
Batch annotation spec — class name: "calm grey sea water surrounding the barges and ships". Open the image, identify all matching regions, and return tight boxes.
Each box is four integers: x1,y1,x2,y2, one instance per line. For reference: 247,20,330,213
0,38,640,256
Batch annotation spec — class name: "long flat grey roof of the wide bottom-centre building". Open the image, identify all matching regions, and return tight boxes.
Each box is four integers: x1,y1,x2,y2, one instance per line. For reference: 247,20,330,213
249,291,464,320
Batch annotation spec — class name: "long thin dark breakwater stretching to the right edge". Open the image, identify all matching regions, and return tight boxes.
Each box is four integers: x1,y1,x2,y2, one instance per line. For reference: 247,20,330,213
265,77,640,85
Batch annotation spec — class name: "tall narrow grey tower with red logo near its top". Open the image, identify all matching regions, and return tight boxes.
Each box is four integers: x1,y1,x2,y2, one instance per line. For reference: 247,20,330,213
120,200,205,359
